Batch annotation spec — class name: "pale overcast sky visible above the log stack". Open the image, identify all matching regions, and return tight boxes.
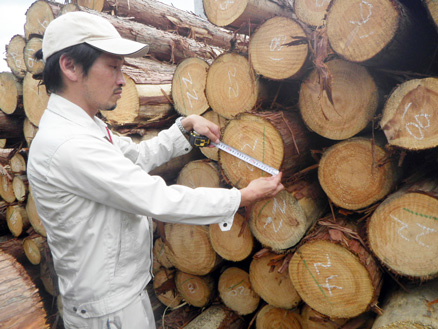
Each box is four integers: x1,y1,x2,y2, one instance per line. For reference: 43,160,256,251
0,0,194,72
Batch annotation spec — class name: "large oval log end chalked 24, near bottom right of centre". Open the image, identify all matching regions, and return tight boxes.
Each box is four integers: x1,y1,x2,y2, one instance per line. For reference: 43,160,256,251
289,240,375,318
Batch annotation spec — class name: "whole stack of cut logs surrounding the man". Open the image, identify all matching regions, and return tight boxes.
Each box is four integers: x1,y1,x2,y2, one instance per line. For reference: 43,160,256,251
0,0,438,329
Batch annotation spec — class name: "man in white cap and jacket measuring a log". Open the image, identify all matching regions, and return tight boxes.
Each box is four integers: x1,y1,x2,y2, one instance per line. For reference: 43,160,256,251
28,12,283,329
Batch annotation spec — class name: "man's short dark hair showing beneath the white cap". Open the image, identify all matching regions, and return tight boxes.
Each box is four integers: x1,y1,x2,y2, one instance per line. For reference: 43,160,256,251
35,43,103,94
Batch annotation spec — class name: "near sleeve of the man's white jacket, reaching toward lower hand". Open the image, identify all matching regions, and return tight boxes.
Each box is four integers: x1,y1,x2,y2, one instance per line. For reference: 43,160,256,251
47,132,241,224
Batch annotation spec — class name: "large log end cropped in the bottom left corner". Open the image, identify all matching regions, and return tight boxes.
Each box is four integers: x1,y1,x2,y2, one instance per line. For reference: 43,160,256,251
0,252,50,329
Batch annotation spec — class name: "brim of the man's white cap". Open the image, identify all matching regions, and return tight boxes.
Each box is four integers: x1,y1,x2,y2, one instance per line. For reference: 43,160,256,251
86,38,149,57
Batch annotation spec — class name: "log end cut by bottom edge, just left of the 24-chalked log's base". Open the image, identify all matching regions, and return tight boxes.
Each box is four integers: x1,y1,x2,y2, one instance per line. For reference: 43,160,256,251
256,305,301,329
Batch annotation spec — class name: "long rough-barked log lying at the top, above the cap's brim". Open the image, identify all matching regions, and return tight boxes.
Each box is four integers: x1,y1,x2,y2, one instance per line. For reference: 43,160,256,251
104,0,248,52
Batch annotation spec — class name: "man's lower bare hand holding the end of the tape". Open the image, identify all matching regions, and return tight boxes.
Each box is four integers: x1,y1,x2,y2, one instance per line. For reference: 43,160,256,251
240,172,284,207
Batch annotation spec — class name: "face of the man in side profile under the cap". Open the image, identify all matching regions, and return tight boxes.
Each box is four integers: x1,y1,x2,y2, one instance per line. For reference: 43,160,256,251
82,53,125,113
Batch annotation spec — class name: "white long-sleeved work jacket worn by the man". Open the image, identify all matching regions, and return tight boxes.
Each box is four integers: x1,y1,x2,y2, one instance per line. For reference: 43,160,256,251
28,94,241,318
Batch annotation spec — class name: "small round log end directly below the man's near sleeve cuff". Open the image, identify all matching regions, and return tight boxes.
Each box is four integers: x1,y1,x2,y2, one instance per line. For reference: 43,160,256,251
209,213,254,262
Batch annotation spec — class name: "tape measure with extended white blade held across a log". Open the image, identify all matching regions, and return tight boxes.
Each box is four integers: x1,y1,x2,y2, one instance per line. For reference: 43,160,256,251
189,131,279,175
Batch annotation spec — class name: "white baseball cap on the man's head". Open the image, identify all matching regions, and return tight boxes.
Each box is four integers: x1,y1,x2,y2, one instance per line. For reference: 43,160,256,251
42,11,149,62
